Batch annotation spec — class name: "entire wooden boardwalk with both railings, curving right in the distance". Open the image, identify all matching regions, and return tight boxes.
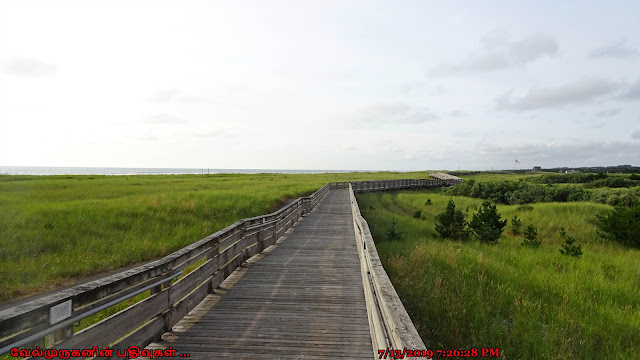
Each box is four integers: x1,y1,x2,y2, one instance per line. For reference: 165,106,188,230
0,174,460,358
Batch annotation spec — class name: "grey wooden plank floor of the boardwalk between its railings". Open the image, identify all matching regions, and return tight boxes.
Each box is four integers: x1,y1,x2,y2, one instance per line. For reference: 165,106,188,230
149,190,373,359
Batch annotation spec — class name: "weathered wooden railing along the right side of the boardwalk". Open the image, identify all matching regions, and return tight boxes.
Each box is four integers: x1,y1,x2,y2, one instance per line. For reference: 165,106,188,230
349,183,426,358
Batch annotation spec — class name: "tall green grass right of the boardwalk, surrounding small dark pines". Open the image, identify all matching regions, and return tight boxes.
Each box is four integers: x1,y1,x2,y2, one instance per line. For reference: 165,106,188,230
358,190,640,359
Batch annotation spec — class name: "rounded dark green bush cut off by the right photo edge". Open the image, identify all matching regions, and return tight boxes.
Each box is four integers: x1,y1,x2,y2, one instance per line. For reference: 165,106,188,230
598,205,640,249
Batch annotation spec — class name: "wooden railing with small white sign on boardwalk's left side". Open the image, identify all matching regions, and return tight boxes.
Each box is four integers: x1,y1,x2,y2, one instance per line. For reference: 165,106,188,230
0,184,330,358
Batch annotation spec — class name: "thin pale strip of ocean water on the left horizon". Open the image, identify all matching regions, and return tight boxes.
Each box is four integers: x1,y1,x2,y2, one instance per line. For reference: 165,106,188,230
0,166,363,175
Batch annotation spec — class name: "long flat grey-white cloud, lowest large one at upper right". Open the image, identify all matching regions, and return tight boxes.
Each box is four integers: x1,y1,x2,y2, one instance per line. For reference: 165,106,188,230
497,79,621,110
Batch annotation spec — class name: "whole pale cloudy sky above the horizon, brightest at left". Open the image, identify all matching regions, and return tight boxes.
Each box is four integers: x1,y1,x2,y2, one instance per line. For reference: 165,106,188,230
0,0,640,170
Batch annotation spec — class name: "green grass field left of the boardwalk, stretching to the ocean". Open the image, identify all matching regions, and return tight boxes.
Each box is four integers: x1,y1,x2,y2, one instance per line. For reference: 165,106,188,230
0,172,428,302
